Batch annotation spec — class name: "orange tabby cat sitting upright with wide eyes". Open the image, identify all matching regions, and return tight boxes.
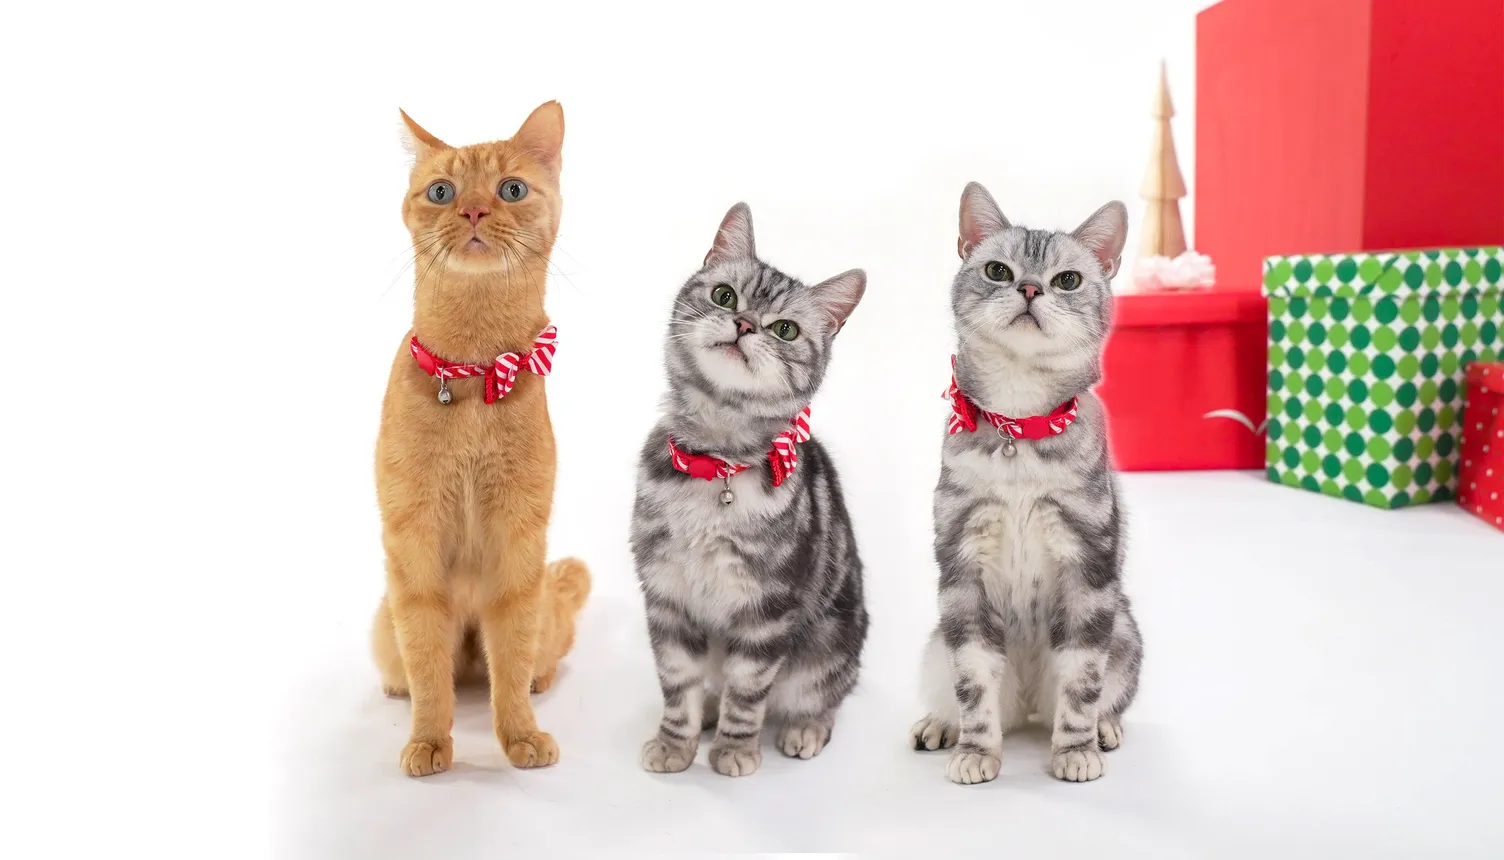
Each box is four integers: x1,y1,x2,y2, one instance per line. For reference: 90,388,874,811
373,102,590,776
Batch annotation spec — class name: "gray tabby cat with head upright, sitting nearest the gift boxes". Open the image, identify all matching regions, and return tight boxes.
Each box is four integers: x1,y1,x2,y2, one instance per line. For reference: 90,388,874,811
910,182,1143,785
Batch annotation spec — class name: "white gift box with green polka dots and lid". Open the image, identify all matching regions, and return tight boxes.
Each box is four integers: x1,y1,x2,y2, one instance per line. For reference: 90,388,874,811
1263,248,1504,508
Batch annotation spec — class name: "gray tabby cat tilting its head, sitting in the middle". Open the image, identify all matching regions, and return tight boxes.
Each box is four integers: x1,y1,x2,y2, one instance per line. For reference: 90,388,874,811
632,203,868,776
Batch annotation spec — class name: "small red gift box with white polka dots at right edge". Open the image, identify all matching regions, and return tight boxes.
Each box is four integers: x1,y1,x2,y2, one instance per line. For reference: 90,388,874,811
1457,361,1504,529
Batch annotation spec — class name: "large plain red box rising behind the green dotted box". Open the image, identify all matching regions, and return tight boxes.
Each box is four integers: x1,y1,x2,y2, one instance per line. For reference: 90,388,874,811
1194,0,1504,284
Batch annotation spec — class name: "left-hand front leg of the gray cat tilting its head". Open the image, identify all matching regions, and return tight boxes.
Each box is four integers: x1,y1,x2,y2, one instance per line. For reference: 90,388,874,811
642,607,710,773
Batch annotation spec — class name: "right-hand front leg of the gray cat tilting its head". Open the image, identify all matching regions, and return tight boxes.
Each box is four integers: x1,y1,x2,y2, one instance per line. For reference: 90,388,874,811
710,639,784,776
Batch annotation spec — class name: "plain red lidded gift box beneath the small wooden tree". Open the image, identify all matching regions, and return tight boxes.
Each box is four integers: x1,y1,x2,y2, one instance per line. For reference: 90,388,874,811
1096,290,1268,472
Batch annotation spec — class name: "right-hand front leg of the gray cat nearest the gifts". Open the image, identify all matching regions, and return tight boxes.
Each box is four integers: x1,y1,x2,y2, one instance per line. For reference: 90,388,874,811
1050,591,1114,782
